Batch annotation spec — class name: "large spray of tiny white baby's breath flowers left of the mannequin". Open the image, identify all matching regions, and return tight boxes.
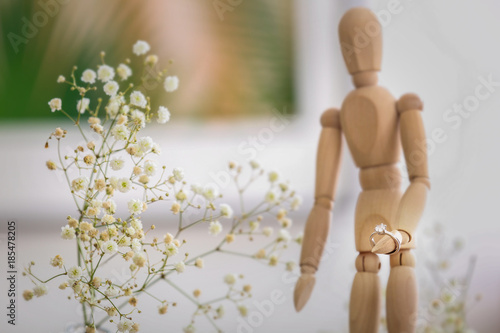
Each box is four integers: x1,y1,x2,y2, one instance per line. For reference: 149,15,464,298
23,41,302,332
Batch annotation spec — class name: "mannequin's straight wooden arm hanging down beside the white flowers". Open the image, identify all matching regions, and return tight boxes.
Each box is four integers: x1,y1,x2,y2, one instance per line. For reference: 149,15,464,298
294,109,342,311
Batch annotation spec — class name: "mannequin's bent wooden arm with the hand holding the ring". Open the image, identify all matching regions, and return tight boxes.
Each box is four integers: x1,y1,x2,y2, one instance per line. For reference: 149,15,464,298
372,94,430,253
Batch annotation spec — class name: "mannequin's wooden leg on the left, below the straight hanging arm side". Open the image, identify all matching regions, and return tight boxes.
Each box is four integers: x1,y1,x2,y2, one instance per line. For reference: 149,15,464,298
349,252,382,333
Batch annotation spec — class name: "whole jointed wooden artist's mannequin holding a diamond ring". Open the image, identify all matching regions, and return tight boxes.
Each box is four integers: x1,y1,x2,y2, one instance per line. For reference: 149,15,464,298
294,8,430,333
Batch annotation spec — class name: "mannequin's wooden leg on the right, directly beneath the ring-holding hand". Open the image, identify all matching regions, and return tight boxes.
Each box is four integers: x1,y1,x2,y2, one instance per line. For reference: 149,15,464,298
386,250,418,333
